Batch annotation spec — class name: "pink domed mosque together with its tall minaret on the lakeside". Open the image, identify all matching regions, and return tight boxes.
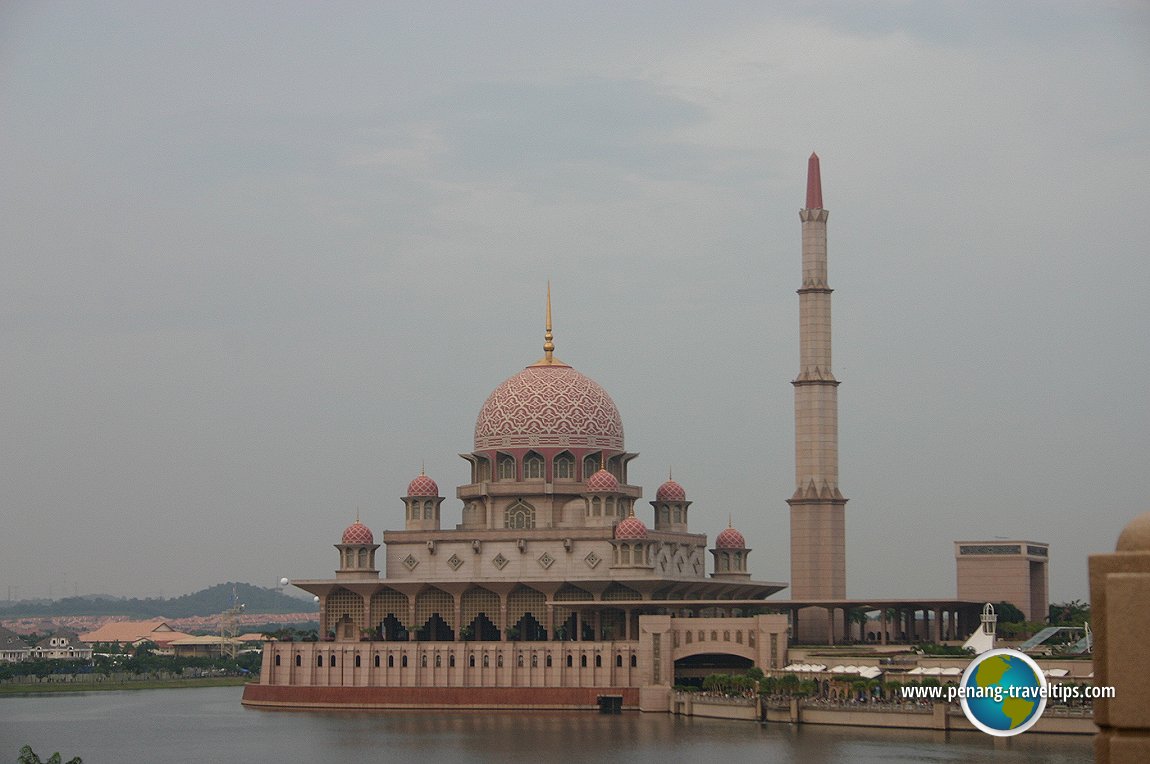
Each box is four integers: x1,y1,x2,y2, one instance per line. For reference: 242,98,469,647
244,155,978,711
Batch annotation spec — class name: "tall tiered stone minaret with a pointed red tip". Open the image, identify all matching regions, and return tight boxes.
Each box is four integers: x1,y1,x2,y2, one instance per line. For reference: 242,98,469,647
787,154,846,642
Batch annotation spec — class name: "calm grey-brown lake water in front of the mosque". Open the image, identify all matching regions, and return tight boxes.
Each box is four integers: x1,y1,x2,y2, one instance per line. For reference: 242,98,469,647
0,687,1093,764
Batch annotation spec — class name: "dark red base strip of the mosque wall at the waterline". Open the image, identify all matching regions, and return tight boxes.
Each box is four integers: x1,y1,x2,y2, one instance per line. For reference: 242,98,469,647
243,683,639,711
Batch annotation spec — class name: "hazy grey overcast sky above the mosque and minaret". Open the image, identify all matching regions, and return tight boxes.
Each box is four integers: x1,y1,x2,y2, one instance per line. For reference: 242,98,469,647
0,0,1150,601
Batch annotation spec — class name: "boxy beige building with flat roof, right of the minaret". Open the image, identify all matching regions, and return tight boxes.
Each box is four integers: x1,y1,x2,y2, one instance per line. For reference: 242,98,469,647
955,540,1050,621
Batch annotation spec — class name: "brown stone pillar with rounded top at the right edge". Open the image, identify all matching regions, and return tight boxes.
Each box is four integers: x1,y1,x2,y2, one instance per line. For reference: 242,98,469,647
1090,512,1150,764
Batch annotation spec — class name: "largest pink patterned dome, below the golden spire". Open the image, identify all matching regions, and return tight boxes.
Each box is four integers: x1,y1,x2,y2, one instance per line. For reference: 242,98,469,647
475,362,623,451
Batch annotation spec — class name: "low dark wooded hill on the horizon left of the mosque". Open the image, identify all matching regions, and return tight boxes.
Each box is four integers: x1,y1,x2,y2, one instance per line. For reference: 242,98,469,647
0,581,319,619
